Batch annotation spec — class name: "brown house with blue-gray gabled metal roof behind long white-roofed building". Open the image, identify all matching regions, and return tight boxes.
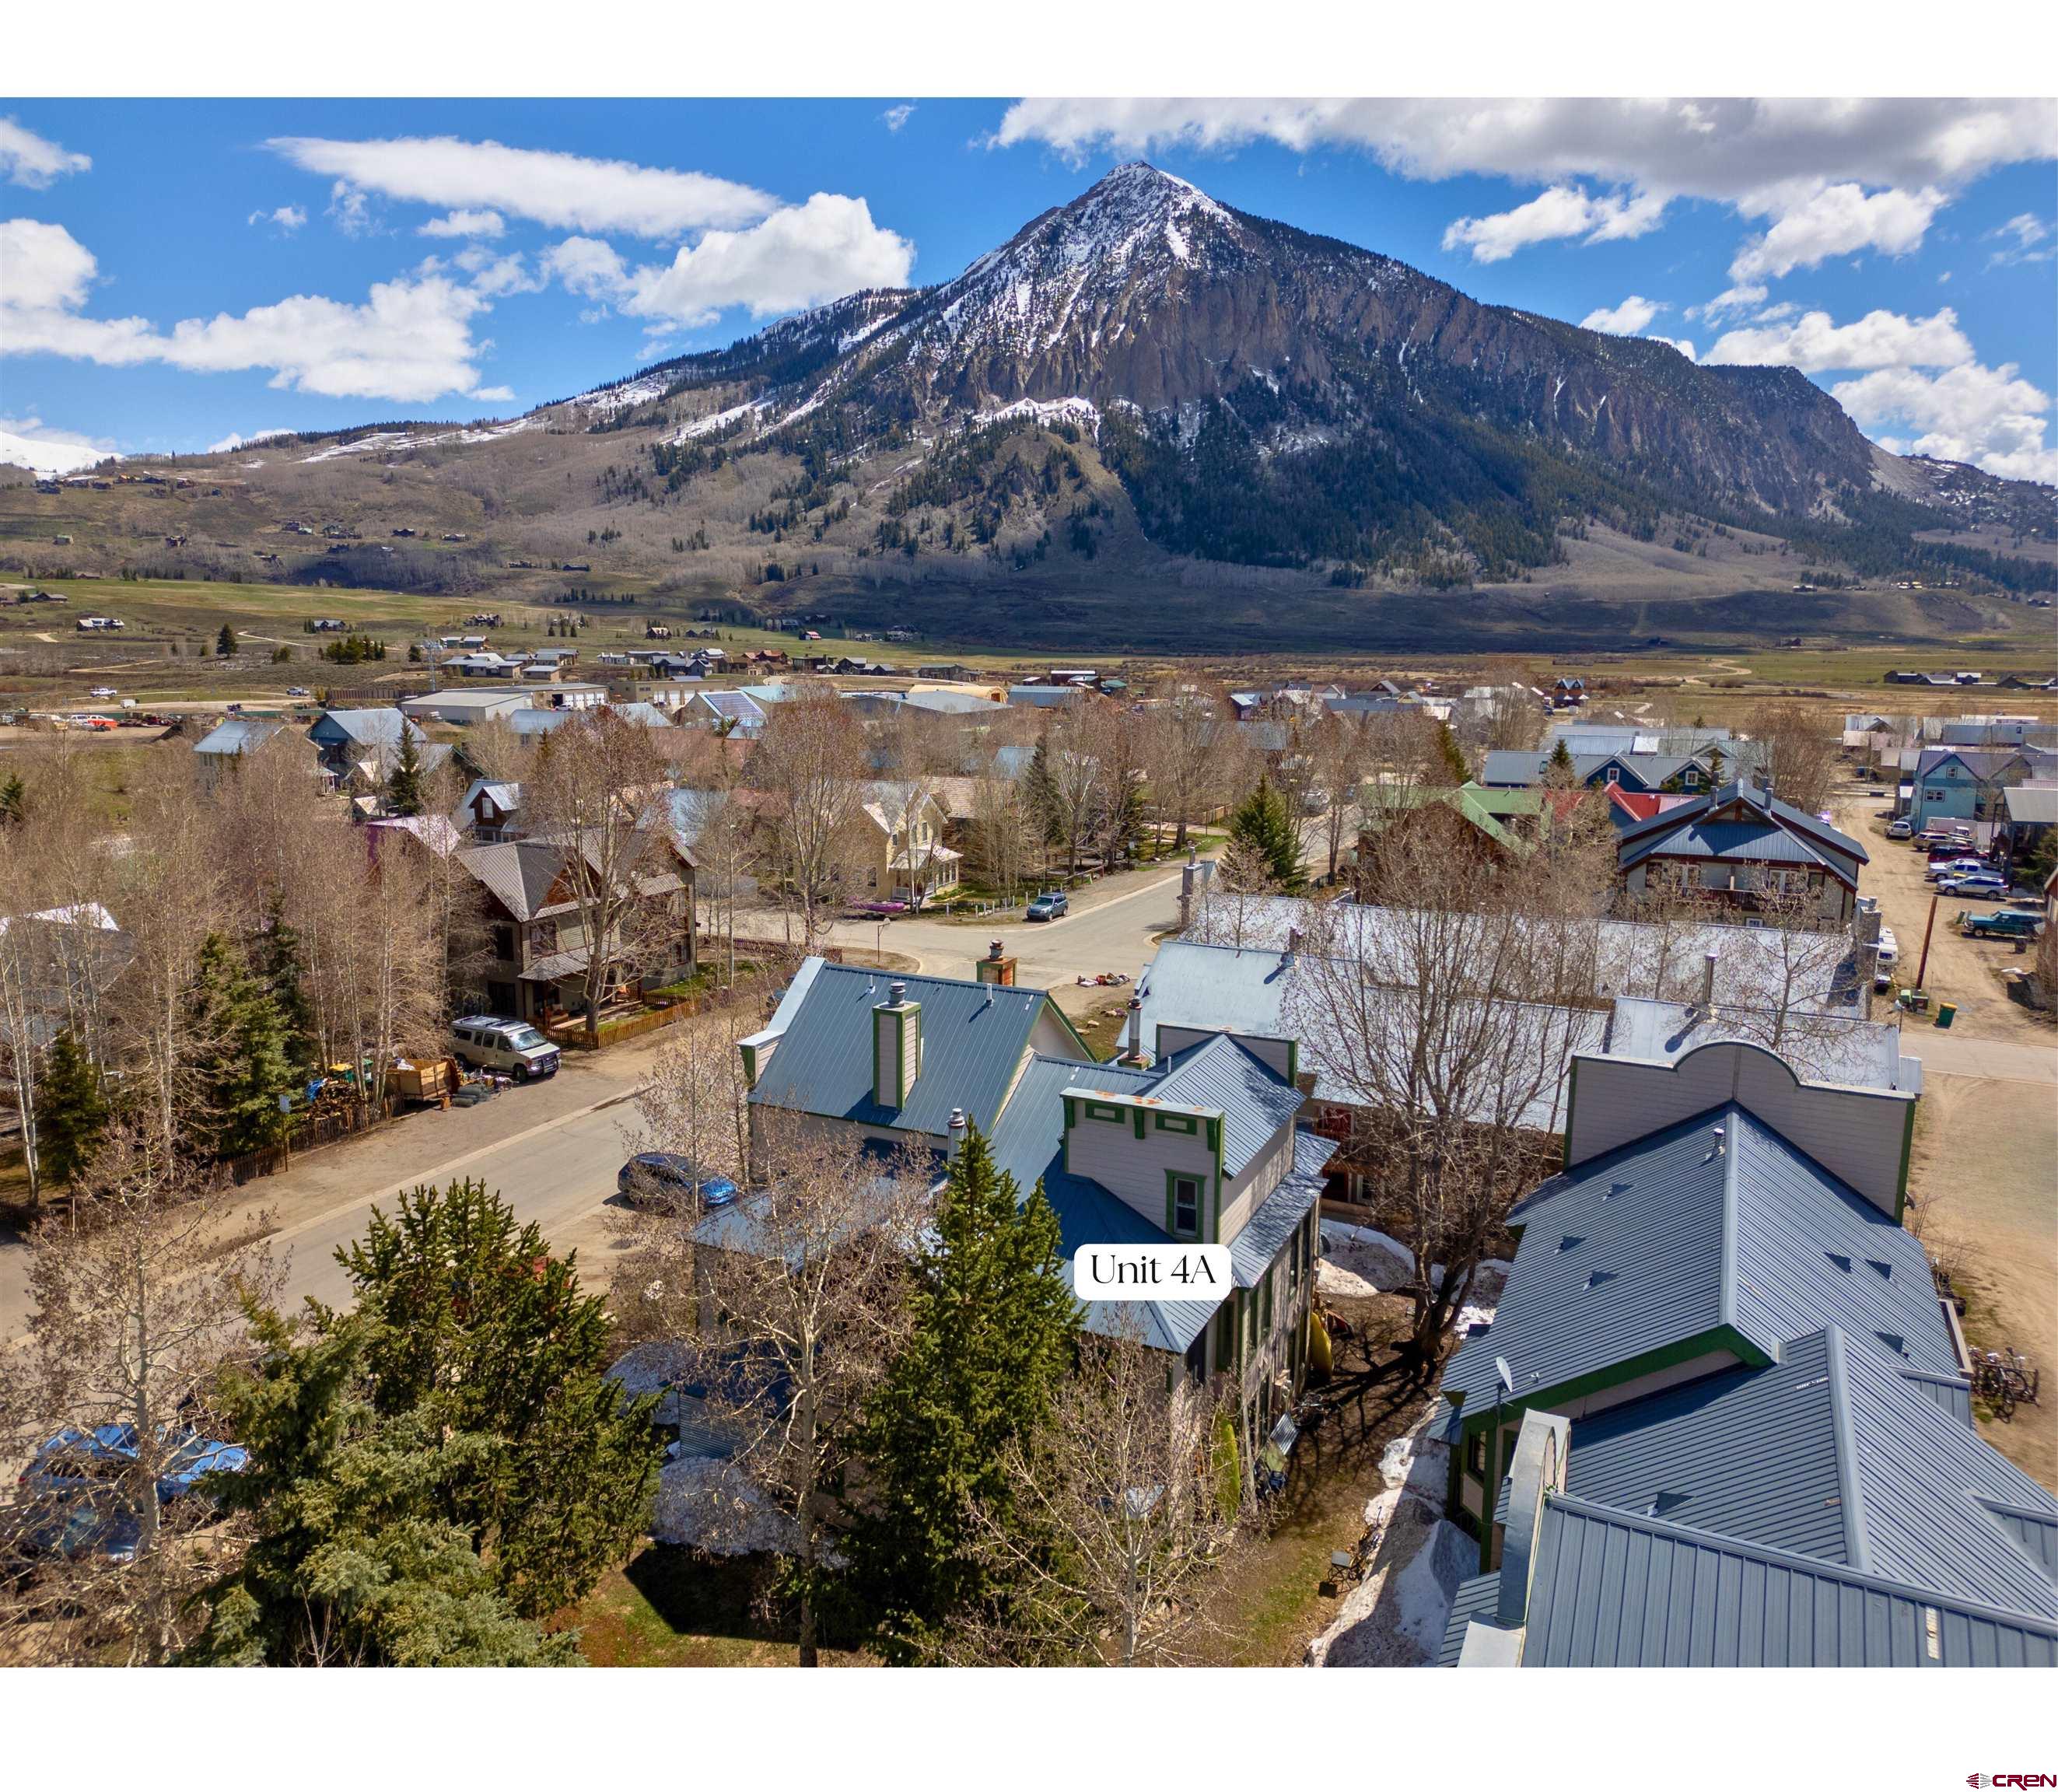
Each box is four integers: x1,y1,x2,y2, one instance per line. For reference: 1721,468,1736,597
1615,780,1871,928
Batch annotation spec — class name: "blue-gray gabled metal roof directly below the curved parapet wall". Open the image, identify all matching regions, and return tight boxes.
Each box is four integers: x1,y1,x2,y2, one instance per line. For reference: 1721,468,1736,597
1443,1103,1957,1409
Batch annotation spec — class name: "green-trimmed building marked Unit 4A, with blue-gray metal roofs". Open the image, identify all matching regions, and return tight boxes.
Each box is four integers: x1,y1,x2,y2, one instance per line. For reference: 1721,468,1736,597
739,959,1334,1413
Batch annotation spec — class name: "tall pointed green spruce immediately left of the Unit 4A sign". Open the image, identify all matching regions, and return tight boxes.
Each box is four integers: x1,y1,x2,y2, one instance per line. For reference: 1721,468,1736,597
848,1128,1079,1662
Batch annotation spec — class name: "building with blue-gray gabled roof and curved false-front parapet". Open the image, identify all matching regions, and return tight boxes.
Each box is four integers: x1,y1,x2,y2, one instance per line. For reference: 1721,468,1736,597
1443,1041,1969,1566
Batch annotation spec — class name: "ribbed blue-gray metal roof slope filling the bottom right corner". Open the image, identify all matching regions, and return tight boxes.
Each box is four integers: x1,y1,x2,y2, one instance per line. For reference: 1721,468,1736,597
1523,1496,2058,1667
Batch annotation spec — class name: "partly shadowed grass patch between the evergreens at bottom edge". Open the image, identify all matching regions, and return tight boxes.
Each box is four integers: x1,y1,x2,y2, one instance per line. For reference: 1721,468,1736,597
551,1543,866,1668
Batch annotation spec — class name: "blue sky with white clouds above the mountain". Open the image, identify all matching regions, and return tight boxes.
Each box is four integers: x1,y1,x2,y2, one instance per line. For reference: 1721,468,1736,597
0,96,2058,484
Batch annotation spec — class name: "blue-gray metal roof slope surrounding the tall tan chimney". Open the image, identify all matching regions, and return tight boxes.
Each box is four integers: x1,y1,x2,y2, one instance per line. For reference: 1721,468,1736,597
751,963,1062,1138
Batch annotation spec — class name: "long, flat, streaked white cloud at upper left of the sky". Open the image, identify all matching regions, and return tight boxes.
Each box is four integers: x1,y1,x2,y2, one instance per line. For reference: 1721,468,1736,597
268,138,778,236
